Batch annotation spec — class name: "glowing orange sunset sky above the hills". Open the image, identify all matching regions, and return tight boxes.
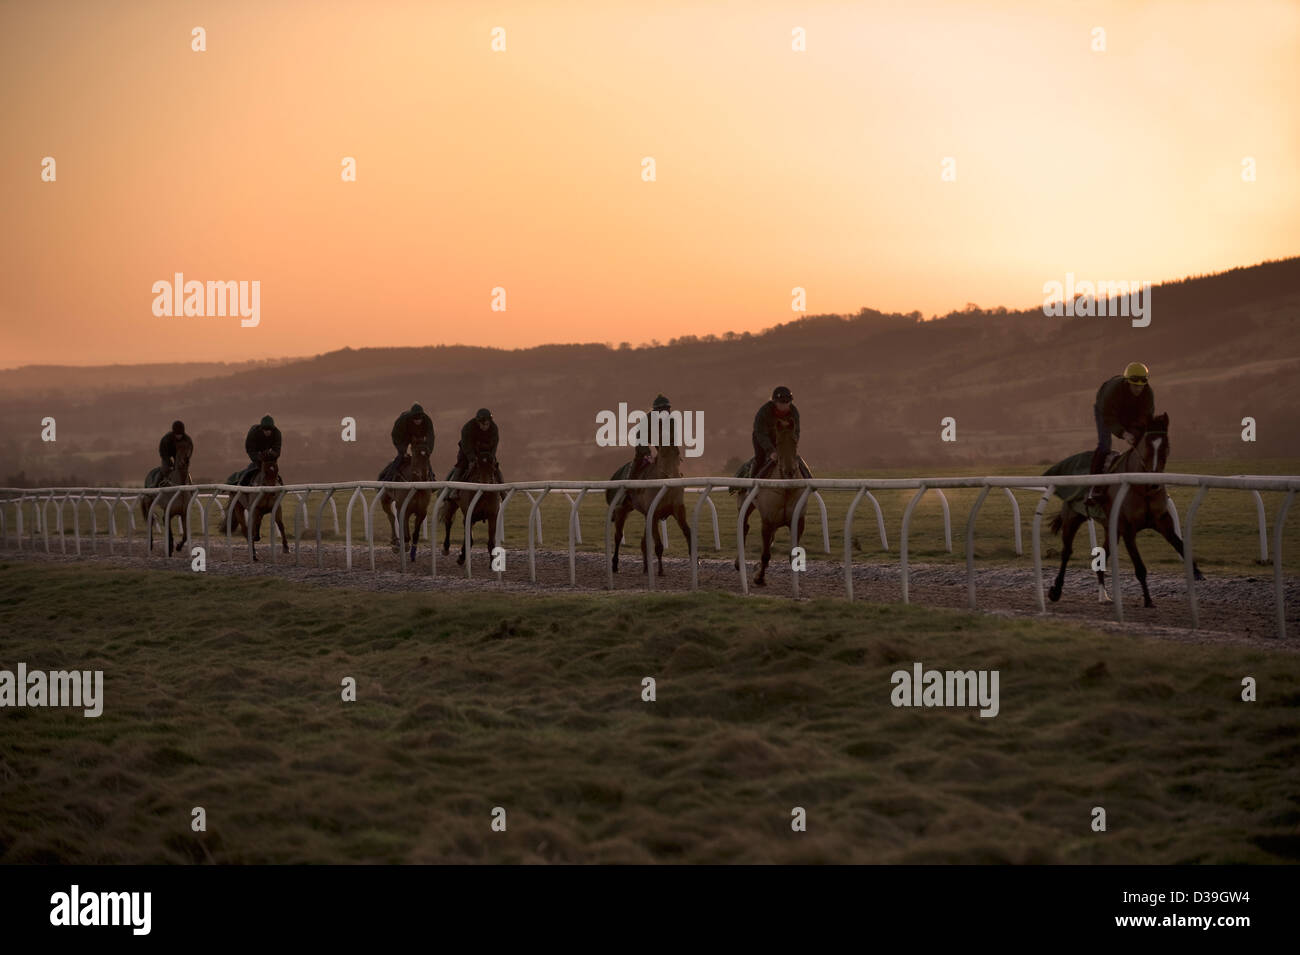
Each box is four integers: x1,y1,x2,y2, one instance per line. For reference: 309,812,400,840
0,0,1300,368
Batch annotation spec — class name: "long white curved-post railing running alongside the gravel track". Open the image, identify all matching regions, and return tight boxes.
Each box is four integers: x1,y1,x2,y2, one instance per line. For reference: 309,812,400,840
0,473,1300,637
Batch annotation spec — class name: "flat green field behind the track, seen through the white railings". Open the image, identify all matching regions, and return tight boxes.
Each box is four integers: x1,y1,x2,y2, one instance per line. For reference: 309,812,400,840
5,459,1300,576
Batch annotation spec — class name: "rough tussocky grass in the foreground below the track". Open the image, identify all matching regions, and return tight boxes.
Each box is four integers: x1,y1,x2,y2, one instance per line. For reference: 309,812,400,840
0,563,1300,863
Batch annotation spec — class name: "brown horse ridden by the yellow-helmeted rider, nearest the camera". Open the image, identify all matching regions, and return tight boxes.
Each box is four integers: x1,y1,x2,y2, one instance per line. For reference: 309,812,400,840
1045,414,1205,607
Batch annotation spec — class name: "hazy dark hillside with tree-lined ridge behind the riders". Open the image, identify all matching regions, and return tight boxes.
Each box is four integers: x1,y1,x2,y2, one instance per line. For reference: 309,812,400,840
0,259,1300,483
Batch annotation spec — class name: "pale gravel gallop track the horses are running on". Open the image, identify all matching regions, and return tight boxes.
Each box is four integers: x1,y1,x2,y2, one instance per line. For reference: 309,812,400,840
0,541,1300,652
